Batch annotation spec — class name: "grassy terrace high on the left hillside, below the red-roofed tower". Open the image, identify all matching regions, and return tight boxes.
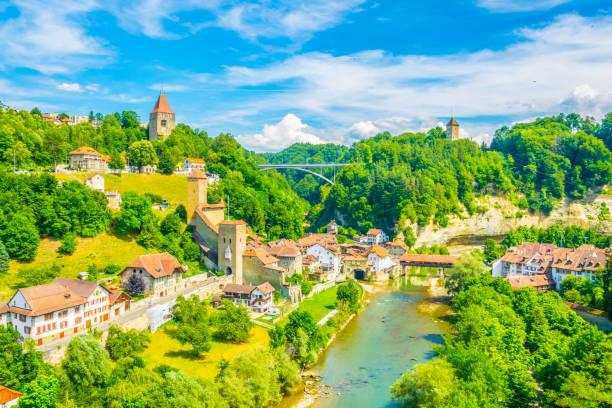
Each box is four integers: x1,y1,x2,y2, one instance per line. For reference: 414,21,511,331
55,173,187,206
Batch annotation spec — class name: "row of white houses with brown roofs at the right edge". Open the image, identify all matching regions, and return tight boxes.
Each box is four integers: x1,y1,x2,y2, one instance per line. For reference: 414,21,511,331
492,242,610,289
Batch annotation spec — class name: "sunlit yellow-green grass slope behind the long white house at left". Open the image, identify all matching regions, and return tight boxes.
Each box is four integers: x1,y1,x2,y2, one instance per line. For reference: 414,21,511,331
0,234,147,300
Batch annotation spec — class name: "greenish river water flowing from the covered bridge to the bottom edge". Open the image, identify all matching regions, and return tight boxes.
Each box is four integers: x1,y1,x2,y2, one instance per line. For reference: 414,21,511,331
313,281,448,408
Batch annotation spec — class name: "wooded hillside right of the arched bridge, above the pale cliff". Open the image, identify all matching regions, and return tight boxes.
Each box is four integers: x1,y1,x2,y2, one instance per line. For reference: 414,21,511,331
267,114,612,237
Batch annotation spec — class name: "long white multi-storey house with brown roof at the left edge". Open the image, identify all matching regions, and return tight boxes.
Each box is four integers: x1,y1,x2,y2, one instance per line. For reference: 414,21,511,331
0,278,119,345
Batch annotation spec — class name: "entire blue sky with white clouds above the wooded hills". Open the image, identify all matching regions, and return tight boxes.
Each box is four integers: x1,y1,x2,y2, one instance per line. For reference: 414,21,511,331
0,0,612,151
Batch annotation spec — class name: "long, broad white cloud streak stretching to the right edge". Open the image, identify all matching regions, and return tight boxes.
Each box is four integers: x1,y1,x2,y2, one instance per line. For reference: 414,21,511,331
216,14,612,146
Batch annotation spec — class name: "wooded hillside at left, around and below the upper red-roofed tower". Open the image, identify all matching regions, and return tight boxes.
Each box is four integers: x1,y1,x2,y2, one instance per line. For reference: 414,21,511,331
0,109,308,242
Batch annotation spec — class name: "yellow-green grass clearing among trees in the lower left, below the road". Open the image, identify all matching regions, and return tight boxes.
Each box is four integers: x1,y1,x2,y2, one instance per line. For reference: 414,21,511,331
141,322,269,380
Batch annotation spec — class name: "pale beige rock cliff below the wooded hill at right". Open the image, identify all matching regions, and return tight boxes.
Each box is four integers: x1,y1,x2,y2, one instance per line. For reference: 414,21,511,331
409,195,612,246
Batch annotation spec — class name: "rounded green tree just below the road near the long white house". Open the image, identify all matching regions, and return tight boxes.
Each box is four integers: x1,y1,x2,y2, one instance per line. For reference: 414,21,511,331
62,336,111,389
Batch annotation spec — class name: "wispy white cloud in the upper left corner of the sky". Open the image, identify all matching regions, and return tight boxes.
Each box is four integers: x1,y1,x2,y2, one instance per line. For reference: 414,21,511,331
0,0,112,74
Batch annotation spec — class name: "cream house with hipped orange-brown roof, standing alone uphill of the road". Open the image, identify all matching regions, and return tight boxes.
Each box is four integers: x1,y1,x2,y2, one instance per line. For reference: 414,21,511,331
120,252,185,297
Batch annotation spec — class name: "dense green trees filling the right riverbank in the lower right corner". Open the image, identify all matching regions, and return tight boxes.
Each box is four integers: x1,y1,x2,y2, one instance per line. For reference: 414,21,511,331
391,272,612,408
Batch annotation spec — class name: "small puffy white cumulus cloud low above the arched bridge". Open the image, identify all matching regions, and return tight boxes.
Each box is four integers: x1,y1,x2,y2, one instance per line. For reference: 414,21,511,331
236,113,324,151
